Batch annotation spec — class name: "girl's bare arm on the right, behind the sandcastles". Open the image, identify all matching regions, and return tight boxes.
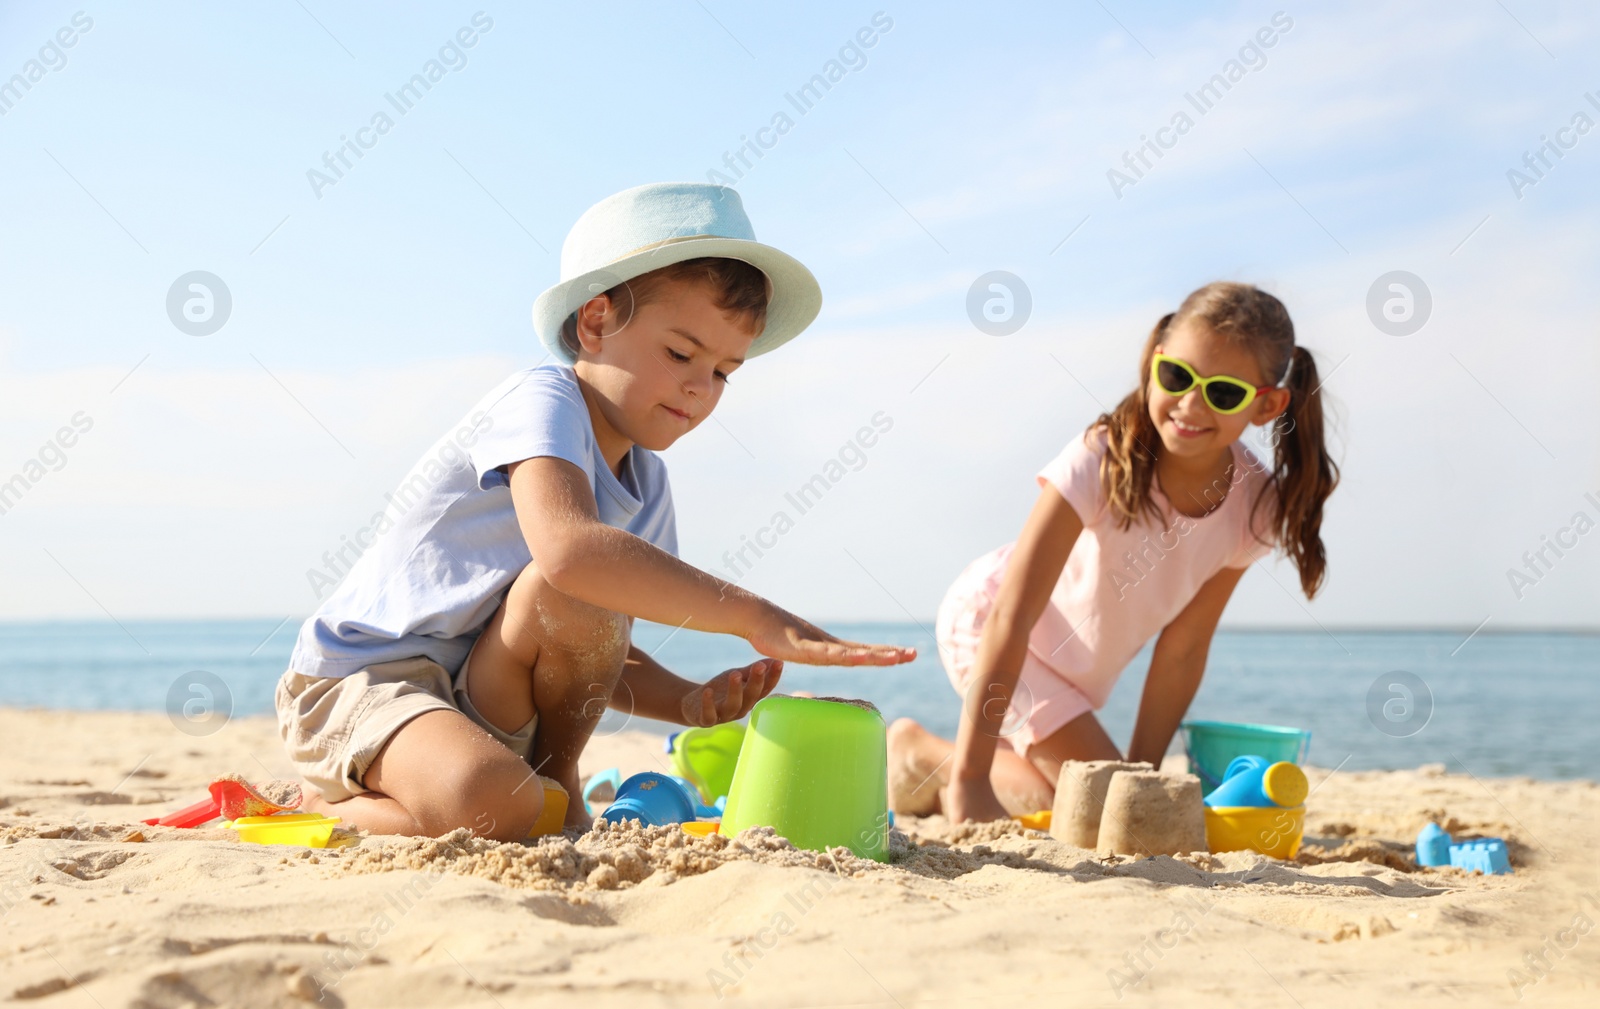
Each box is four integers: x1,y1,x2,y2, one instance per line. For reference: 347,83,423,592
1128,568,1248,768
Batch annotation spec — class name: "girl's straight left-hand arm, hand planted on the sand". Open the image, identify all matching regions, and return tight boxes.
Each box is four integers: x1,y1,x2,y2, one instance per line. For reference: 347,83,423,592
944,486,1083,822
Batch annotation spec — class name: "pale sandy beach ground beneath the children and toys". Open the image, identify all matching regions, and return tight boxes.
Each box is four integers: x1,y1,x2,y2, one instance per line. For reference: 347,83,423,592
0,710,1600,1009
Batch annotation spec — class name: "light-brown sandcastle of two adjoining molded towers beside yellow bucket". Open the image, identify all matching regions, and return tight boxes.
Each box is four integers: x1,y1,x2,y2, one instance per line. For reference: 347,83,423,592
1050,760,1206,855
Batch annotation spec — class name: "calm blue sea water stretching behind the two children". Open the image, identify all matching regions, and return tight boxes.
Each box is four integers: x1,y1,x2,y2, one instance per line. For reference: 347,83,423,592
0,620,1600,779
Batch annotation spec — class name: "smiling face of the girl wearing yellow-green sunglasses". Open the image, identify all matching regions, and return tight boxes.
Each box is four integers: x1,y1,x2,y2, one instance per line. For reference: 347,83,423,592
1144,321,1290,457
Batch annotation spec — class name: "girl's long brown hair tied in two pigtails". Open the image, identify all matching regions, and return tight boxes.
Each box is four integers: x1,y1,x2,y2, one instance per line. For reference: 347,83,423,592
1088,281,1339,600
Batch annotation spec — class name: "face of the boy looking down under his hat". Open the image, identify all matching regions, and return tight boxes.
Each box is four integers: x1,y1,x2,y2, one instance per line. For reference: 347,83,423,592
574,281,757,451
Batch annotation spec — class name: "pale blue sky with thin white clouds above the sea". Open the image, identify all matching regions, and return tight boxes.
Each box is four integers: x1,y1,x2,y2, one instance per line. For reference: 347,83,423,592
0,0,1600,628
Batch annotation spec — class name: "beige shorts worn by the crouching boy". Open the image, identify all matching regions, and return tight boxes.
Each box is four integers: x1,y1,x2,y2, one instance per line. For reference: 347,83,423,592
274,657,539,803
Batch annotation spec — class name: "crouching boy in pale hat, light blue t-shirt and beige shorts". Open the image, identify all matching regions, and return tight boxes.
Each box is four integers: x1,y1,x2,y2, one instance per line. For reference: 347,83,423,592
277,182,915,841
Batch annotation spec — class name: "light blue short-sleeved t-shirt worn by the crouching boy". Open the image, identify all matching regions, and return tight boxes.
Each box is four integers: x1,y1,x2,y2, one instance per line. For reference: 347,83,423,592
290,363,678,676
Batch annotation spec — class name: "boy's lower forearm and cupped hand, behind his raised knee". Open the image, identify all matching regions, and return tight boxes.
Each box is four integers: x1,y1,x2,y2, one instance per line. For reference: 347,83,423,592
611,646,784,726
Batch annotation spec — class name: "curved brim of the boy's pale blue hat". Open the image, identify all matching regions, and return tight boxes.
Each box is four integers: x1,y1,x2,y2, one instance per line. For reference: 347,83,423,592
533,237,822,365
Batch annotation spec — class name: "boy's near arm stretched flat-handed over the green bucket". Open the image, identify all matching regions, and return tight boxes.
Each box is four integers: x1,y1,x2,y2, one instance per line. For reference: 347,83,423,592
507,457,917,665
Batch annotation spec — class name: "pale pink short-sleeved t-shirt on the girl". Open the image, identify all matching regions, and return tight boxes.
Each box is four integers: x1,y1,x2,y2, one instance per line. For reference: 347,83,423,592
974,429,1275,708
